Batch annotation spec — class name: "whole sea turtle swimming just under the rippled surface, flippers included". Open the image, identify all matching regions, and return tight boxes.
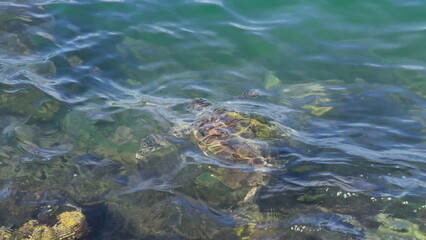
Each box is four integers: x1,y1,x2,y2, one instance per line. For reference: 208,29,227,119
136,91,286,203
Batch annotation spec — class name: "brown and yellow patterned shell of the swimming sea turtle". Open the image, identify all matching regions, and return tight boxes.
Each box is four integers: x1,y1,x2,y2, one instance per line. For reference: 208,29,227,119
193,110,279,166
